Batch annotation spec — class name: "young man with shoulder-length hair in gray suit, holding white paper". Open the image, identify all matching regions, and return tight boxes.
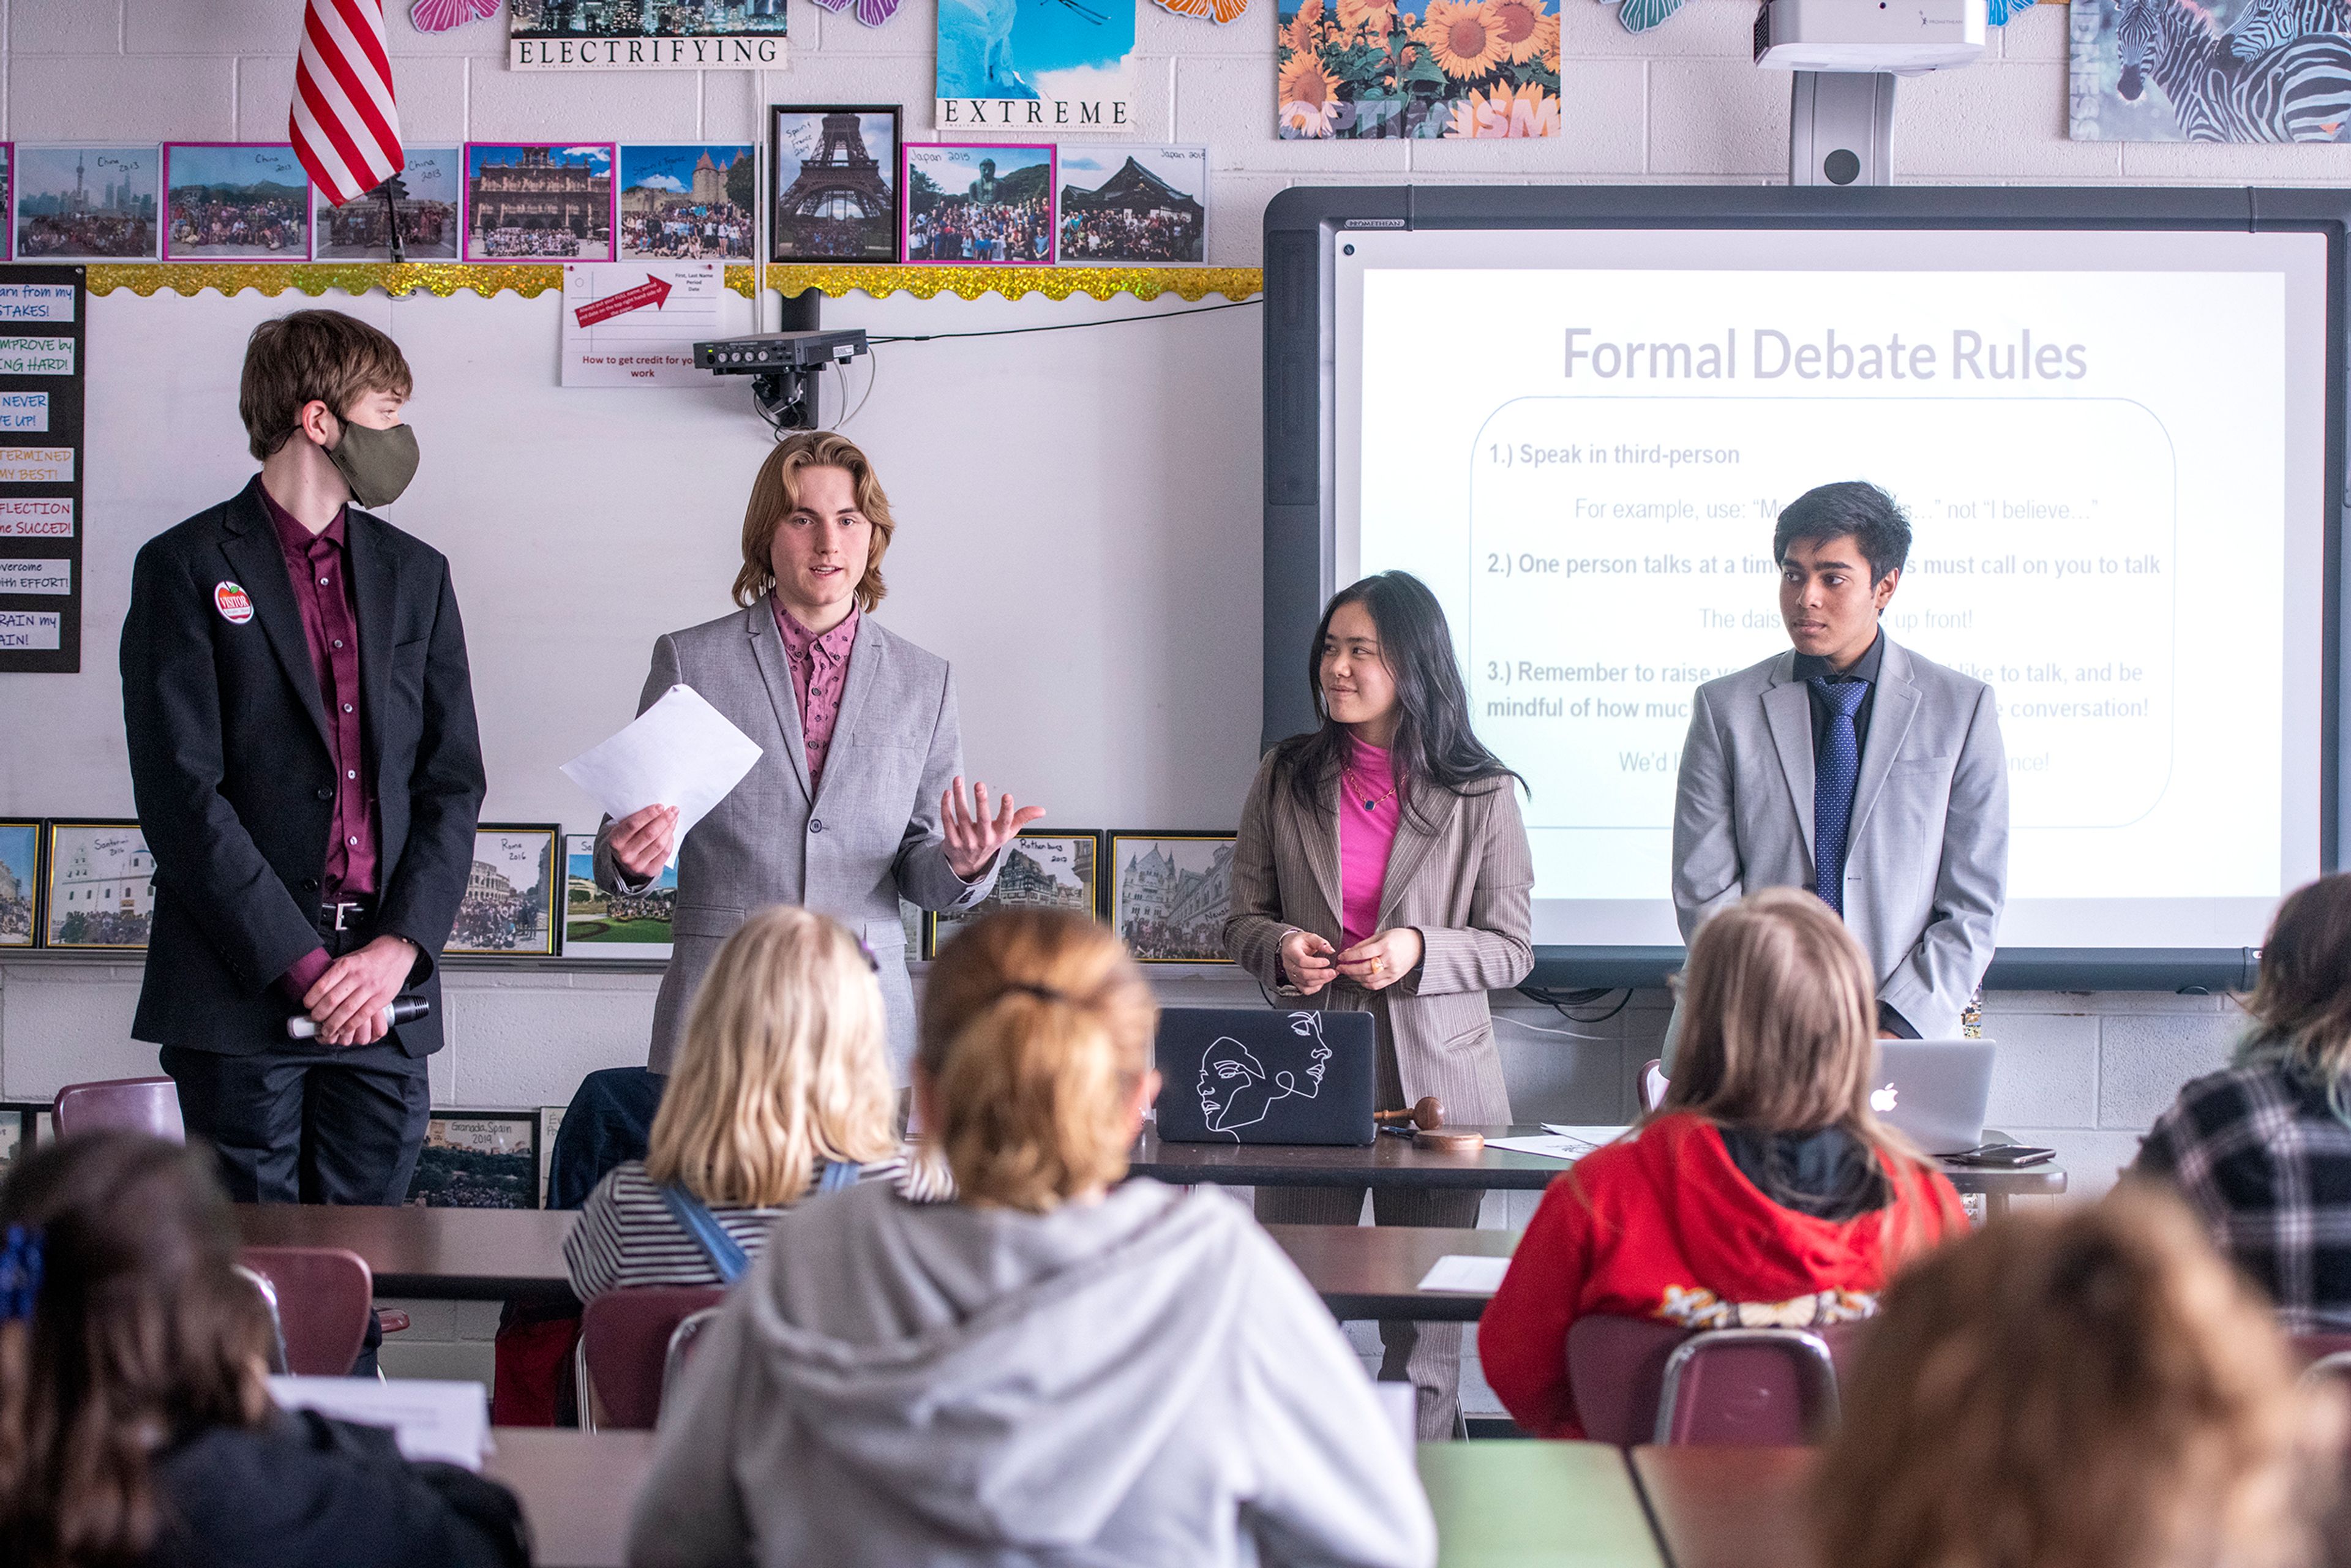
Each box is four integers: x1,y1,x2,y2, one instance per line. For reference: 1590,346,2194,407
595,432,1044,1086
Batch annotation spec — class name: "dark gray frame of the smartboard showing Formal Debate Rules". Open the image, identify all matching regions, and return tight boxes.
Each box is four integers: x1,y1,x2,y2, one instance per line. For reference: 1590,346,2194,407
1262,186,2351,989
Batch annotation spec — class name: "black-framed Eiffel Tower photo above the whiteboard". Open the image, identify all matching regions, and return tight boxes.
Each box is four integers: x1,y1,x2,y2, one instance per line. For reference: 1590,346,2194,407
767,103,901,261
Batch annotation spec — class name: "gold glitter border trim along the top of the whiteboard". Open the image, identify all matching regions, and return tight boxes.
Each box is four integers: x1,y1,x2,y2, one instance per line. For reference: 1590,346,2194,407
84,261,1265,301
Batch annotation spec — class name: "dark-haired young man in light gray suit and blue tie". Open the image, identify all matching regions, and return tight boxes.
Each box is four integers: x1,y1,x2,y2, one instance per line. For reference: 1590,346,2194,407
1674,479,2008,1039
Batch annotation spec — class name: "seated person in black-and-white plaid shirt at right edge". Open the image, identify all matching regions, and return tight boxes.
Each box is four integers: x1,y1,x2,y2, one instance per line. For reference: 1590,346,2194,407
2132,874,2351,1333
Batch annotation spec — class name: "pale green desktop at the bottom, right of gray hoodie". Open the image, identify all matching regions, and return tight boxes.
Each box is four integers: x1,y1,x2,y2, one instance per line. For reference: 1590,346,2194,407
1420,1439,1688,1568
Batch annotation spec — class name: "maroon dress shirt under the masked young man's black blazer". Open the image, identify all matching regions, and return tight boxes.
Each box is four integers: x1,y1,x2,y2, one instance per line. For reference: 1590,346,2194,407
254,479,378,1002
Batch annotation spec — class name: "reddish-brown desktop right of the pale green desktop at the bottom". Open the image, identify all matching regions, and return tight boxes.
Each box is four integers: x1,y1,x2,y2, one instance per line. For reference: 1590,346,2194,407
1632,1448,1815,1568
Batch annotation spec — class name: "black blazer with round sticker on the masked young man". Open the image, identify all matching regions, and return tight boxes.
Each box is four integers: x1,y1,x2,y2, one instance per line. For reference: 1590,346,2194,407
122,477,484,1056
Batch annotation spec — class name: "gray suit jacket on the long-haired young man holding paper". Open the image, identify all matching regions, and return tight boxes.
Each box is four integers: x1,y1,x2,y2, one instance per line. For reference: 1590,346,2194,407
595,597,997,1084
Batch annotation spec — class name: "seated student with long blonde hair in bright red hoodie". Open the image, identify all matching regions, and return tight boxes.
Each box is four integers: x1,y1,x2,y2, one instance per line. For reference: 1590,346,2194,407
1477,888,1968,1436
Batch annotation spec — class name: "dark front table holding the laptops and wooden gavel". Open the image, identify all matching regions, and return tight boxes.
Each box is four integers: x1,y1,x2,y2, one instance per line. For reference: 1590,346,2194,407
1128,1126,2064,1218
